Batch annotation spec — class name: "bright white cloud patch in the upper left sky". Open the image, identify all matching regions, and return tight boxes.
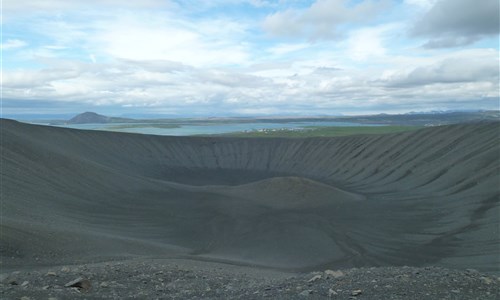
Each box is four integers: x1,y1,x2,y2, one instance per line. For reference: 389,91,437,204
27,12,249,66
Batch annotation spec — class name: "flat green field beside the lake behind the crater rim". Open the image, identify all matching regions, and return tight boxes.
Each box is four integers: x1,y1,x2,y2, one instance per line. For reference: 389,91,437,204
218,126,423,138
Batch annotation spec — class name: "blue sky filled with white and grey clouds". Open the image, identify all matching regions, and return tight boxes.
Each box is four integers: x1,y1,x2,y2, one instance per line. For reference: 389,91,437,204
1,0,500,117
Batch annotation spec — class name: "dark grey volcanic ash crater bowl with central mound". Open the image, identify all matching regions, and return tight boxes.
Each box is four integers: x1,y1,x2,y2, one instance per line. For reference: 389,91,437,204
0,120,500,272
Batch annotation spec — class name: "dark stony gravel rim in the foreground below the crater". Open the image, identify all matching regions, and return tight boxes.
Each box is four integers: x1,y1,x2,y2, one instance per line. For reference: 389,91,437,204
0,259,500,300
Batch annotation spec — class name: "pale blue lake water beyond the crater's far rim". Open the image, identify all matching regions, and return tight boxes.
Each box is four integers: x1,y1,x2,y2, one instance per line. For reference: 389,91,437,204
51,121,380,136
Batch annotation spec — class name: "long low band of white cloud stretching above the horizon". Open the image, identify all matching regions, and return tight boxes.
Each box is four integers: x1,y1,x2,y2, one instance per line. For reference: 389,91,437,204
4,50,499,114
